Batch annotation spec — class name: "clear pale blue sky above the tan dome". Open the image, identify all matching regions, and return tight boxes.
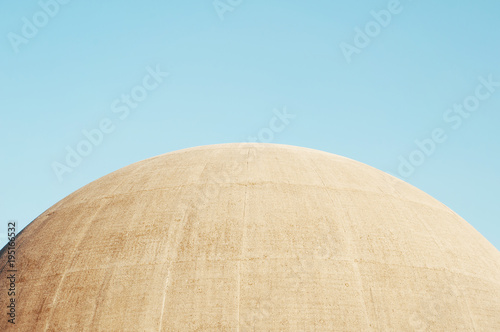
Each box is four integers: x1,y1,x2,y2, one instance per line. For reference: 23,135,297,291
0,0,500,248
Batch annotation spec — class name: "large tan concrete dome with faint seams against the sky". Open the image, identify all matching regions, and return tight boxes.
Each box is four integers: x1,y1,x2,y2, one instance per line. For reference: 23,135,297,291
0,144,500,331
